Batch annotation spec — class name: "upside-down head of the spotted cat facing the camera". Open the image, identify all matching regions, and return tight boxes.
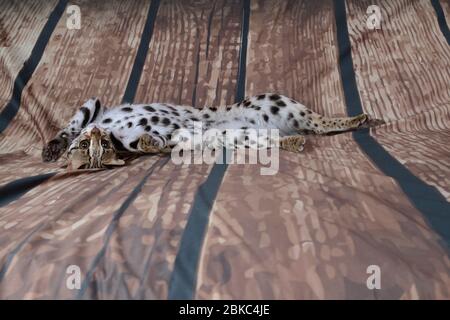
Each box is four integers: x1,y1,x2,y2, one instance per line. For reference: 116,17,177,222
67,125,125,170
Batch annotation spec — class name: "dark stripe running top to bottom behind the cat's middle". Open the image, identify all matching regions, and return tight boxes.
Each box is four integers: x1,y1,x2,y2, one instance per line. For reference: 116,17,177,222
168,0,250,299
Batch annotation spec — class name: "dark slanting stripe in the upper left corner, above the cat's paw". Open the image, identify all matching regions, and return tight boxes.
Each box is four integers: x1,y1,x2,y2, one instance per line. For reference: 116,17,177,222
0,0,67,134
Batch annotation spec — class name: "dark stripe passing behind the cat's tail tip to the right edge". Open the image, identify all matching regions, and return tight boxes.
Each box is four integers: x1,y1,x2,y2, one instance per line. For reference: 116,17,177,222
334,0,450,248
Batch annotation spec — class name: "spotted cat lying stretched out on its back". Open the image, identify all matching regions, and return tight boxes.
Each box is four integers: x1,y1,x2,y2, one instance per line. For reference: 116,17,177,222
42,93,382,169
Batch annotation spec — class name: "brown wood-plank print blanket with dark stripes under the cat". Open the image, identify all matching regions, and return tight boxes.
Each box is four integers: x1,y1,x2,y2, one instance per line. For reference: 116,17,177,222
0,0,450,299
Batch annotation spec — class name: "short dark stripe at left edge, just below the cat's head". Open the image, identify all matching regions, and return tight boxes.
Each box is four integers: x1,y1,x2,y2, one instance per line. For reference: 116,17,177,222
0,172,56,207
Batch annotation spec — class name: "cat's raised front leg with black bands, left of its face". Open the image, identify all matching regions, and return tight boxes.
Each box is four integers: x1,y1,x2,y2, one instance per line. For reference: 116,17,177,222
42,98,103,162
